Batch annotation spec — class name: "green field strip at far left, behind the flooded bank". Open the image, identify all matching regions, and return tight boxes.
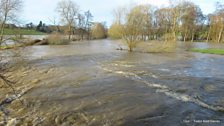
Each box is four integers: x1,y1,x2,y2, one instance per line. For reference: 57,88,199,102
4,28,46,35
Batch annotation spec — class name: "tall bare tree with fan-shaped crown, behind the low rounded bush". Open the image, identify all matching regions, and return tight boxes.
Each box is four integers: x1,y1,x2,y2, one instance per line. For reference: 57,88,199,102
56,0,79,40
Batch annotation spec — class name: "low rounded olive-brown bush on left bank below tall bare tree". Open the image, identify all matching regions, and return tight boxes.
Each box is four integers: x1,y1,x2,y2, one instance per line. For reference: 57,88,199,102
46,33,69,45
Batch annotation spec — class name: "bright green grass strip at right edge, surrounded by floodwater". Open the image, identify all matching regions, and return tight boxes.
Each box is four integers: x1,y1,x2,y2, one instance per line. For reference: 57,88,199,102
190,49,224,55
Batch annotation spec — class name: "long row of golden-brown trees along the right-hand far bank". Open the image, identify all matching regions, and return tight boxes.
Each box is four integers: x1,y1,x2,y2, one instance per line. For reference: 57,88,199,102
108,0,224,46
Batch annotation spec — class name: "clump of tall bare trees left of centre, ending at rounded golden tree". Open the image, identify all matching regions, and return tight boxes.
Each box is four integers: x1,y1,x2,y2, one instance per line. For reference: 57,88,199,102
56,0,107,40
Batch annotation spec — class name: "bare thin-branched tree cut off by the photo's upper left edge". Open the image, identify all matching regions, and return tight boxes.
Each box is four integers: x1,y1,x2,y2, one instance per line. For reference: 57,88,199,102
0,0,22,41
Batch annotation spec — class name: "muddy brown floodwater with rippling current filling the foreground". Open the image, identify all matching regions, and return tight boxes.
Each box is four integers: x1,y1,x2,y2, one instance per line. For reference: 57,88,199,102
0,40,224,126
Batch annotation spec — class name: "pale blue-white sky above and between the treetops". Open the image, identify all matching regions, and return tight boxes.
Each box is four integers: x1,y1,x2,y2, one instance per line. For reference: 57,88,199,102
21,0,220,25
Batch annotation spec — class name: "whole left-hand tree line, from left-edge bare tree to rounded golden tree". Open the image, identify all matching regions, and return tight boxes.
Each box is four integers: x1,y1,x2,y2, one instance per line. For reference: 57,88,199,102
0,0,107,41
